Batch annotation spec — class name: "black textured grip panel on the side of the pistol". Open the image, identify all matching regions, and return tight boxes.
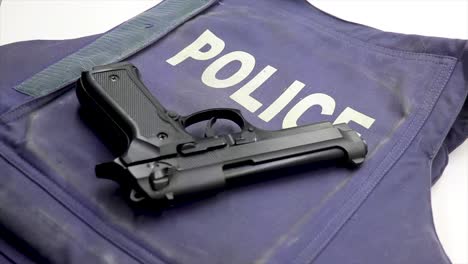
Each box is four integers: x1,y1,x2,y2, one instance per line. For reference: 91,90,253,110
93,69,170,138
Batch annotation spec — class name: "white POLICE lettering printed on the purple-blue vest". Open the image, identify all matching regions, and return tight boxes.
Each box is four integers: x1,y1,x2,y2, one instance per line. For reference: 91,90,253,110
166,30,375,129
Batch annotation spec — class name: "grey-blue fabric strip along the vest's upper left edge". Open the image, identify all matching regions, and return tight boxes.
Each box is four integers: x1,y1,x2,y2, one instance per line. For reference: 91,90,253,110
15,0,216,97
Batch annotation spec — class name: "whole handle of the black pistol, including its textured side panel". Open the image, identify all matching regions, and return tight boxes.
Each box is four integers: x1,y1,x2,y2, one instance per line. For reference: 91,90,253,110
77,63,190,163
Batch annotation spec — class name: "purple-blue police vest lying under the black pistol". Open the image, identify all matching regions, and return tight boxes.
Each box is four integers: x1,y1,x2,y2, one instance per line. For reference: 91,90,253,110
0,0,468,264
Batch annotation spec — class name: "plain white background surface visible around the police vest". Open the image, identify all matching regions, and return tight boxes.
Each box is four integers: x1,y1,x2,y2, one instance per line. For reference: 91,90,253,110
0,0,468,264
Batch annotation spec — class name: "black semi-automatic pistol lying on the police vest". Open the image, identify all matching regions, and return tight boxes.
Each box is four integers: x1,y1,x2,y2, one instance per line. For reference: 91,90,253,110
76,62,367,202
